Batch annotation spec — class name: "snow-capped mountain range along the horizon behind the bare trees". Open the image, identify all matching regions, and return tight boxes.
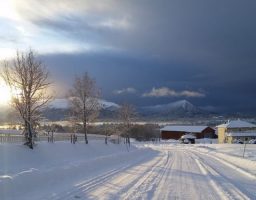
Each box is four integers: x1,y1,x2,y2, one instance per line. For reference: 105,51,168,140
0,98,255,123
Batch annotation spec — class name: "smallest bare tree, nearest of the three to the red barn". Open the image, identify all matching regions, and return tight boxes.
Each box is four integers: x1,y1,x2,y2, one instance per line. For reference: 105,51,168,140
118,103,136,145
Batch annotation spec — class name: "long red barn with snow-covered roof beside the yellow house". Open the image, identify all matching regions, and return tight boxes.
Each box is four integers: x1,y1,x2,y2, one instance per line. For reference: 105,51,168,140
160,126,217,140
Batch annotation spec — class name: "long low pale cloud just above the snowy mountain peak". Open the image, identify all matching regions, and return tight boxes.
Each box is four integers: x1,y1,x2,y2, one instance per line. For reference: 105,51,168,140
142,87,205,97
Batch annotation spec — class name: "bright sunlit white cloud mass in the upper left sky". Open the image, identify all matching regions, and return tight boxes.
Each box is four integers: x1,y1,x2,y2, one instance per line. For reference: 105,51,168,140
0,0,131,58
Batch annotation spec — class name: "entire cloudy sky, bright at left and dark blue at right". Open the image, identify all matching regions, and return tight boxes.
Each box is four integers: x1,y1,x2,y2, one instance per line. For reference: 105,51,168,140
0,0,256,113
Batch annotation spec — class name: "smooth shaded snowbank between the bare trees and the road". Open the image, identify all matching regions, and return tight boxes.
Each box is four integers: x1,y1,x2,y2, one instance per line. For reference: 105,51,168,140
0,141,158,200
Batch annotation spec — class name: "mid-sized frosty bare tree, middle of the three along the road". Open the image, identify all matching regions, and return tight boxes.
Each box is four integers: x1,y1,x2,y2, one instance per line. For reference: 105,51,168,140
69,72,100,144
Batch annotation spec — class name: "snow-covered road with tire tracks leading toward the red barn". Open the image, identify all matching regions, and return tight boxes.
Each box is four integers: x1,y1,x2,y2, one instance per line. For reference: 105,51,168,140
44,147,256,200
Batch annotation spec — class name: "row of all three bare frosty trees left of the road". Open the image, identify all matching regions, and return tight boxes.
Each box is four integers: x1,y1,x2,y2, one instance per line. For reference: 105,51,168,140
1,49,146,149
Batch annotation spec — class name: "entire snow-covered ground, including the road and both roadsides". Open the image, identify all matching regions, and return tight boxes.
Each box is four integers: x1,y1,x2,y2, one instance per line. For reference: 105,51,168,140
0,140,256,200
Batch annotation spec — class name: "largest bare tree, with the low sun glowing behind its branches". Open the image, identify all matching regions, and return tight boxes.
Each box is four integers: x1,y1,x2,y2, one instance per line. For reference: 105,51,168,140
1,50,52,149
